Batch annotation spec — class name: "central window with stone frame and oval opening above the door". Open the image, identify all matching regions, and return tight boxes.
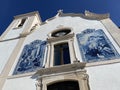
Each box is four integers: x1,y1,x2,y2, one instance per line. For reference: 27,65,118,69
46,28,76,67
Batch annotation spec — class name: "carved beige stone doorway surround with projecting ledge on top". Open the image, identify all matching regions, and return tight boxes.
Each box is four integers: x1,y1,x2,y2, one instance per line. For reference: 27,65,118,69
33,62,90,90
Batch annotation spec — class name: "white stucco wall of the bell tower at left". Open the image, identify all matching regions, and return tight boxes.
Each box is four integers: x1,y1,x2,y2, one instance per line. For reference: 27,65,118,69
0,16,30,73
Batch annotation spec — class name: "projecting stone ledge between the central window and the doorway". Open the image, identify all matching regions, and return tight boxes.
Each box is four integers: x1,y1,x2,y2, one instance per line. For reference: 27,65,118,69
33,62,86,76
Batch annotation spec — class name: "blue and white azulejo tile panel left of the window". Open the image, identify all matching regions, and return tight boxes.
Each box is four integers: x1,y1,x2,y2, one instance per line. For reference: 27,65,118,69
13,40,46,74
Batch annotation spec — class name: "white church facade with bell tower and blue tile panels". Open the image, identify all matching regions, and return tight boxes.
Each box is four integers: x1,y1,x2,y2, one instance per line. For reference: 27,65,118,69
0,10,120,90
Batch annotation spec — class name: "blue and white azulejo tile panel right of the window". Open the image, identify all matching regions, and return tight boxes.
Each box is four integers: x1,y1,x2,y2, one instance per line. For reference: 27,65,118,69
76,29,120,62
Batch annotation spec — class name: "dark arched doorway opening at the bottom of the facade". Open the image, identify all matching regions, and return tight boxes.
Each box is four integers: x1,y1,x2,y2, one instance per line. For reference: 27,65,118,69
47,81,79,90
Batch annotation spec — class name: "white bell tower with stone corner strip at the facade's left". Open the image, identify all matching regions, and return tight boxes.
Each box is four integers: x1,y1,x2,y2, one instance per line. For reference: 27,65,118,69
0,11,41,90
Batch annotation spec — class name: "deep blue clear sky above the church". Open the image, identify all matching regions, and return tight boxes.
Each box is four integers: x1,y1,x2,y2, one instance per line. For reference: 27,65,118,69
0,0,120,35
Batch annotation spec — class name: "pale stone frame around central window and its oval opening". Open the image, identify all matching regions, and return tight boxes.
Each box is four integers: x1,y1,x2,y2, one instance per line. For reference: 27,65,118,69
45,27,77,67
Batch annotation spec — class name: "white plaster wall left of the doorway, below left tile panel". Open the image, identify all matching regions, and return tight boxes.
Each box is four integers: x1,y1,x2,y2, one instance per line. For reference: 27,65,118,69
2,77,36,90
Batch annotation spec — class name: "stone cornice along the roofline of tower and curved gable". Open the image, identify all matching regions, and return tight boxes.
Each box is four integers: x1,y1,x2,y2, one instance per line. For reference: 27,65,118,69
14,10,110,25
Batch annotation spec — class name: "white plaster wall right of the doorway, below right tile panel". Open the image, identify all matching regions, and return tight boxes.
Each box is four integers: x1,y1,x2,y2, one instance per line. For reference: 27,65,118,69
87,63,120,90
